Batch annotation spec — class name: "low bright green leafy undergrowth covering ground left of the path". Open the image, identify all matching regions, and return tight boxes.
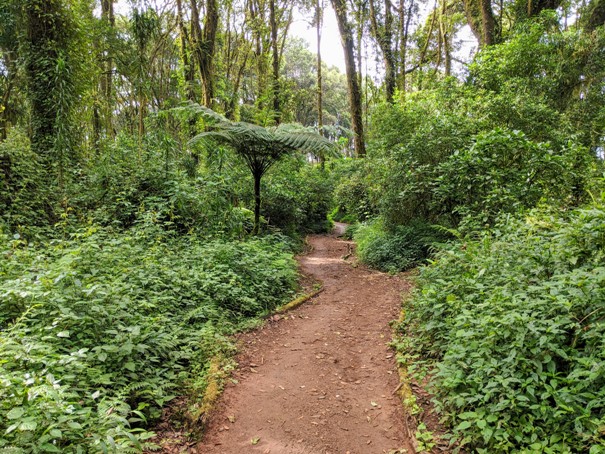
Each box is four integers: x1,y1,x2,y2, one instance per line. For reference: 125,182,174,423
0,225,296,452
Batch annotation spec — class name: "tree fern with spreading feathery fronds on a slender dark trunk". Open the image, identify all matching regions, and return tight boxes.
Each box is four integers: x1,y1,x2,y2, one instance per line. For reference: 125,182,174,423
189,104,337,234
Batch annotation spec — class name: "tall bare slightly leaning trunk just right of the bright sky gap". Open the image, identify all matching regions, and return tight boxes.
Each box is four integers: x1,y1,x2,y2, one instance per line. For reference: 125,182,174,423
330,0,366,157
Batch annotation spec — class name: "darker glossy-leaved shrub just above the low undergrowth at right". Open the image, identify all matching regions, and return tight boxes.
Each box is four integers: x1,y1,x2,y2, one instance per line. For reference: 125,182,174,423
433,129,591,225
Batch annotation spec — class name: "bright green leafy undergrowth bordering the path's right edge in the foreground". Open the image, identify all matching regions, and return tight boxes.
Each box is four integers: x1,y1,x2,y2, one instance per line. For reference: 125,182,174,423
405,202,605,453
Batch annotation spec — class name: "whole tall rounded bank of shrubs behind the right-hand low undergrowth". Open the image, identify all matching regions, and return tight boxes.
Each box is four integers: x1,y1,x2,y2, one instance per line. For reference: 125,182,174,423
367,82,599,226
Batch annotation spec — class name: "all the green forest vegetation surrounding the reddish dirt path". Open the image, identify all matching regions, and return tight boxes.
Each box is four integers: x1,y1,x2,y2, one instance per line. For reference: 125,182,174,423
0,0,605,454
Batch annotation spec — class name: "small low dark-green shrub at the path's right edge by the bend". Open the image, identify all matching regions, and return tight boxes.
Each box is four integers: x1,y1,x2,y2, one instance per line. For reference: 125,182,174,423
353,220,443,272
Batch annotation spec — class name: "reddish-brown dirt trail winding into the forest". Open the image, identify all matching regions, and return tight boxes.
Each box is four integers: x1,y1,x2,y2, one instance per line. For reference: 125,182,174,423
193,227,414,454
